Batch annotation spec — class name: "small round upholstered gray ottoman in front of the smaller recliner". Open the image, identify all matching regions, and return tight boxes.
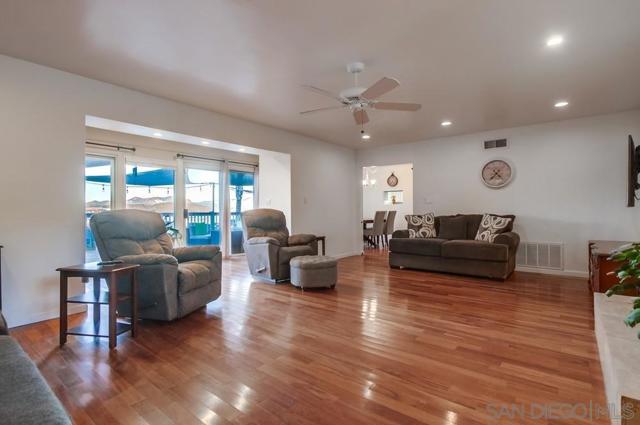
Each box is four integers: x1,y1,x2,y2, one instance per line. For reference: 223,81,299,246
289,255,338,289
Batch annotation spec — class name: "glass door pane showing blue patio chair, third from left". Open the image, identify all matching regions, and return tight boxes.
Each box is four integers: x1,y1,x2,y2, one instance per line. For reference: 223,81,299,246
184,168,221,246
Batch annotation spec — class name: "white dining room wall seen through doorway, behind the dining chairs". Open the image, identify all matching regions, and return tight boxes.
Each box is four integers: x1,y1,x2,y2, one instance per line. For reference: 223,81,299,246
362,164,413,229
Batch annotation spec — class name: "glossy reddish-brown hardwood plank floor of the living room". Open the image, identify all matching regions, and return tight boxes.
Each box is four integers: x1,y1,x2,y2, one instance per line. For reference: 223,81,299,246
12,251,608,425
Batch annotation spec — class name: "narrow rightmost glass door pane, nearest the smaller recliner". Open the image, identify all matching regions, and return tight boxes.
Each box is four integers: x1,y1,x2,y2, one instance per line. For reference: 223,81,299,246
229,170,255,254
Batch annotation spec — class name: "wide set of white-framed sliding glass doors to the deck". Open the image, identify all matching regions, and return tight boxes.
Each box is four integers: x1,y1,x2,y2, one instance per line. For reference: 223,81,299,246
85,149,258,262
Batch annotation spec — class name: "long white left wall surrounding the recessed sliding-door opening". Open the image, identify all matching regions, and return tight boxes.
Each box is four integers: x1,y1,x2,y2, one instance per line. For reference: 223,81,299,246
0,55,360,326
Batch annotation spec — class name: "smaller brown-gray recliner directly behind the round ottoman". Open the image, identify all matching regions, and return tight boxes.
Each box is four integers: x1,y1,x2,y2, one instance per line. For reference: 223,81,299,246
242,208,318,282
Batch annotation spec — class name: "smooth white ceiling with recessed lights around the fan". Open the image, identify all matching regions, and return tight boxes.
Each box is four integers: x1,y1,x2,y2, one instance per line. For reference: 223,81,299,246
0,0,640,148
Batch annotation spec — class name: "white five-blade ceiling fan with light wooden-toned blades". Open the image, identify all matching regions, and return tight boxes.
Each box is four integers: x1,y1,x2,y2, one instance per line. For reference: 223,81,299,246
300,62,422,130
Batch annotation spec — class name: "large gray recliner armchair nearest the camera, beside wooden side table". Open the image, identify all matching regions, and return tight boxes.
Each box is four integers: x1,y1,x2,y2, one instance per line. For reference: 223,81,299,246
90,210,222,320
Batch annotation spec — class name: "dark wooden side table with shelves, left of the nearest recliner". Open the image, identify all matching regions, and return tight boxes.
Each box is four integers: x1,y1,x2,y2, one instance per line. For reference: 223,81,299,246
57,263,140,349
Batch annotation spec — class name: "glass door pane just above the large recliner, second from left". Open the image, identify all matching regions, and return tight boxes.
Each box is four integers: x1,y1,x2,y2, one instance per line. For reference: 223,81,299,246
126,163,176,227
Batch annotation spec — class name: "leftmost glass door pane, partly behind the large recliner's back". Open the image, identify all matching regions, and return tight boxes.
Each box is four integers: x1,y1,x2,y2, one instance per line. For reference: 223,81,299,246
84,156,113,263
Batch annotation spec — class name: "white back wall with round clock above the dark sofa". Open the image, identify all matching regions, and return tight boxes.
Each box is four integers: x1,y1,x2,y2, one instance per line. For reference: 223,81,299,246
358,110,640,274
